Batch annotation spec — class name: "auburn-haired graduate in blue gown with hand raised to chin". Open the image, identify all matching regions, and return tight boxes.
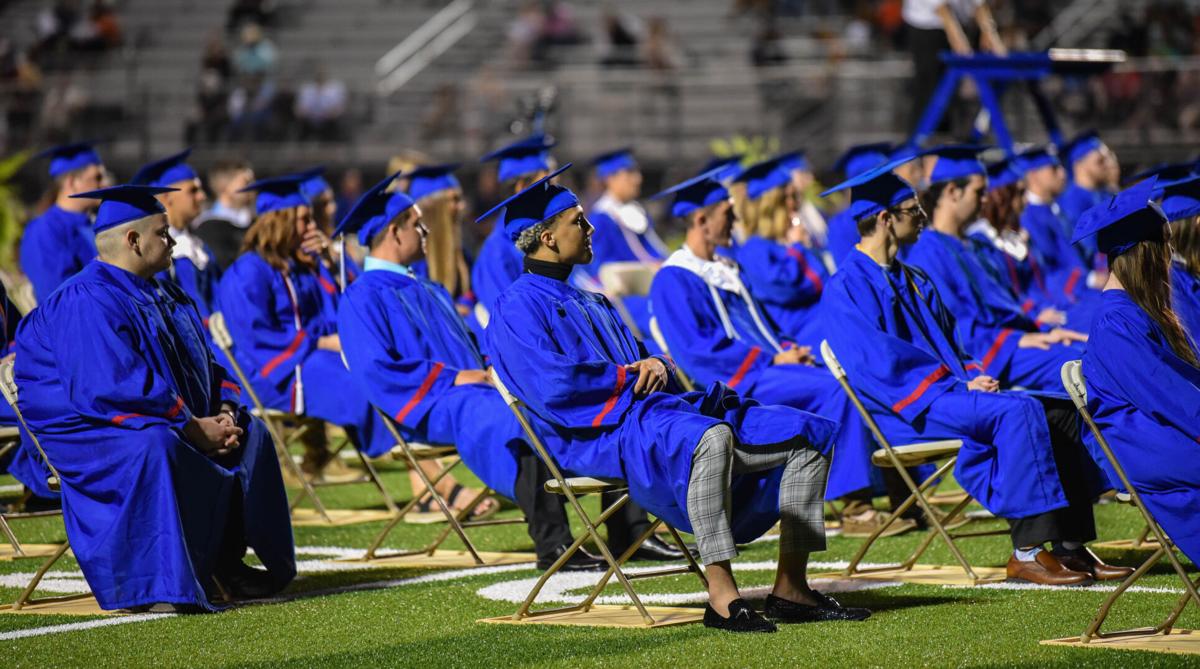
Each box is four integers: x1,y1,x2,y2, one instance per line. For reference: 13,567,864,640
217,176,395,458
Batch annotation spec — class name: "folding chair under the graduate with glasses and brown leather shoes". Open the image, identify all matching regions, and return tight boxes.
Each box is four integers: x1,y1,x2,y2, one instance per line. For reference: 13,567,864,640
821,340,1008,585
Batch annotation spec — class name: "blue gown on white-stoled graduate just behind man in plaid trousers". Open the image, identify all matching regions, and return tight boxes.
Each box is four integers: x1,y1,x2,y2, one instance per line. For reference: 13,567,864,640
650,256,875,500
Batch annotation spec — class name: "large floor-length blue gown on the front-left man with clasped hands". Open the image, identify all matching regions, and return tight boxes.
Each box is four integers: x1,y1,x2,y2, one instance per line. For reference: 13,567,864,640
16,261,295,609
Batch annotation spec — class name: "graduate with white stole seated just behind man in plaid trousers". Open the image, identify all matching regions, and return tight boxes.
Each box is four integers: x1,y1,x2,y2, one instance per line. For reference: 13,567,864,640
650,175,875,499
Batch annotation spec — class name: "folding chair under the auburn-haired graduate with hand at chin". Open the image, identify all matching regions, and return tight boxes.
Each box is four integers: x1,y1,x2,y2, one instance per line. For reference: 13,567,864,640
209,312,398,524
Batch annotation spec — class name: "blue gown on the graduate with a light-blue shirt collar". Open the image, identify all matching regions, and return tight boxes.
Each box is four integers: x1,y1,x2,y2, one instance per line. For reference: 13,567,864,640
337,270,523,499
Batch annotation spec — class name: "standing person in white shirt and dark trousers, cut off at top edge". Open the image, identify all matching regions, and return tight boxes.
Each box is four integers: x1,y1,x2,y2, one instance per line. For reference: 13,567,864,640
902,0,1008,123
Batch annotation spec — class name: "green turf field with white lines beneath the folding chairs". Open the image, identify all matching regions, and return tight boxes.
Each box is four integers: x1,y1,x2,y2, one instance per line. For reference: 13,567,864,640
0,465,1200,669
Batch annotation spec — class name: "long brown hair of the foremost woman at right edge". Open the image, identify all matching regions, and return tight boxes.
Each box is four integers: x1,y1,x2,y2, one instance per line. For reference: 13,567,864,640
1109,240,1200,367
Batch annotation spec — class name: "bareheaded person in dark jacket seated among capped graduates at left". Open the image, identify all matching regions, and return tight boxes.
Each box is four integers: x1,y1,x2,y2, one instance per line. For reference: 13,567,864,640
192,159,254,270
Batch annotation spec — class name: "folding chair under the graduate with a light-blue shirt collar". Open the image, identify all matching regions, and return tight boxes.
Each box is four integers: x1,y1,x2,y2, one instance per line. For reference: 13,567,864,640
350,406,526,567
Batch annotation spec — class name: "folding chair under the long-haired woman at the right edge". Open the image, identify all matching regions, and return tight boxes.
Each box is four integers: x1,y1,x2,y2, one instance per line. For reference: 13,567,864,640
1062,360,1200,644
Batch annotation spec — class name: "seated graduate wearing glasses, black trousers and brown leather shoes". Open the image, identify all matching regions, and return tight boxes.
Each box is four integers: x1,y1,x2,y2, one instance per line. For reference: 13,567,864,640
821,164,1130,585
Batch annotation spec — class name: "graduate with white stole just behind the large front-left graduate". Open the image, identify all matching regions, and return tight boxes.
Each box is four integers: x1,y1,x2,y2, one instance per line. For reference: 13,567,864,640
130,149,221,324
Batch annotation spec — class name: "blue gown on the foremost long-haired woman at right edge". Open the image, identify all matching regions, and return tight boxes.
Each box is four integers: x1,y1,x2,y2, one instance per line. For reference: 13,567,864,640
1084,290,1200,563
